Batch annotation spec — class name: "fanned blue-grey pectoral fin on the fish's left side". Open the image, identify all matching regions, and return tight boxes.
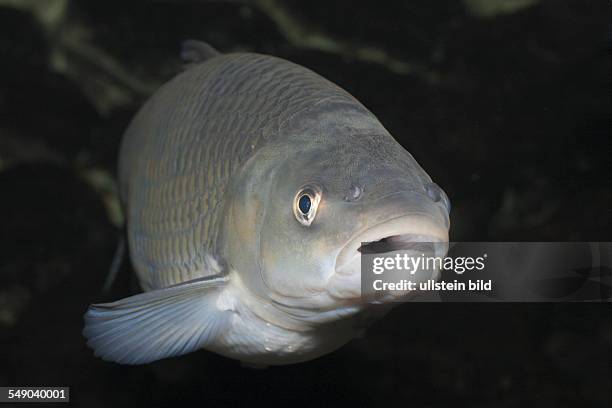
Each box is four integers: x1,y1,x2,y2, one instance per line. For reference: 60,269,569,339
83,277,232,364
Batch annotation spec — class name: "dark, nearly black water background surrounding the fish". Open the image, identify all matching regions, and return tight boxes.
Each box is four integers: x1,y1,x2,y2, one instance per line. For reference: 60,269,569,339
0,0,612,407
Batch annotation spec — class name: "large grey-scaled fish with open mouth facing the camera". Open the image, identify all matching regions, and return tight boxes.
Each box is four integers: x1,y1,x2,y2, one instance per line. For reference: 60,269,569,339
83,40,450,366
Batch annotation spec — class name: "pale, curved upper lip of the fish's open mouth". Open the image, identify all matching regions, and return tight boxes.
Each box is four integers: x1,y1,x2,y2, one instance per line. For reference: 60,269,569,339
335,213,448,273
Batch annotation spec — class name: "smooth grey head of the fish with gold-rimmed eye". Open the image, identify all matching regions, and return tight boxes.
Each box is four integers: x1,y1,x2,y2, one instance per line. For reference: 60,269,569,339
230,134,450,319
